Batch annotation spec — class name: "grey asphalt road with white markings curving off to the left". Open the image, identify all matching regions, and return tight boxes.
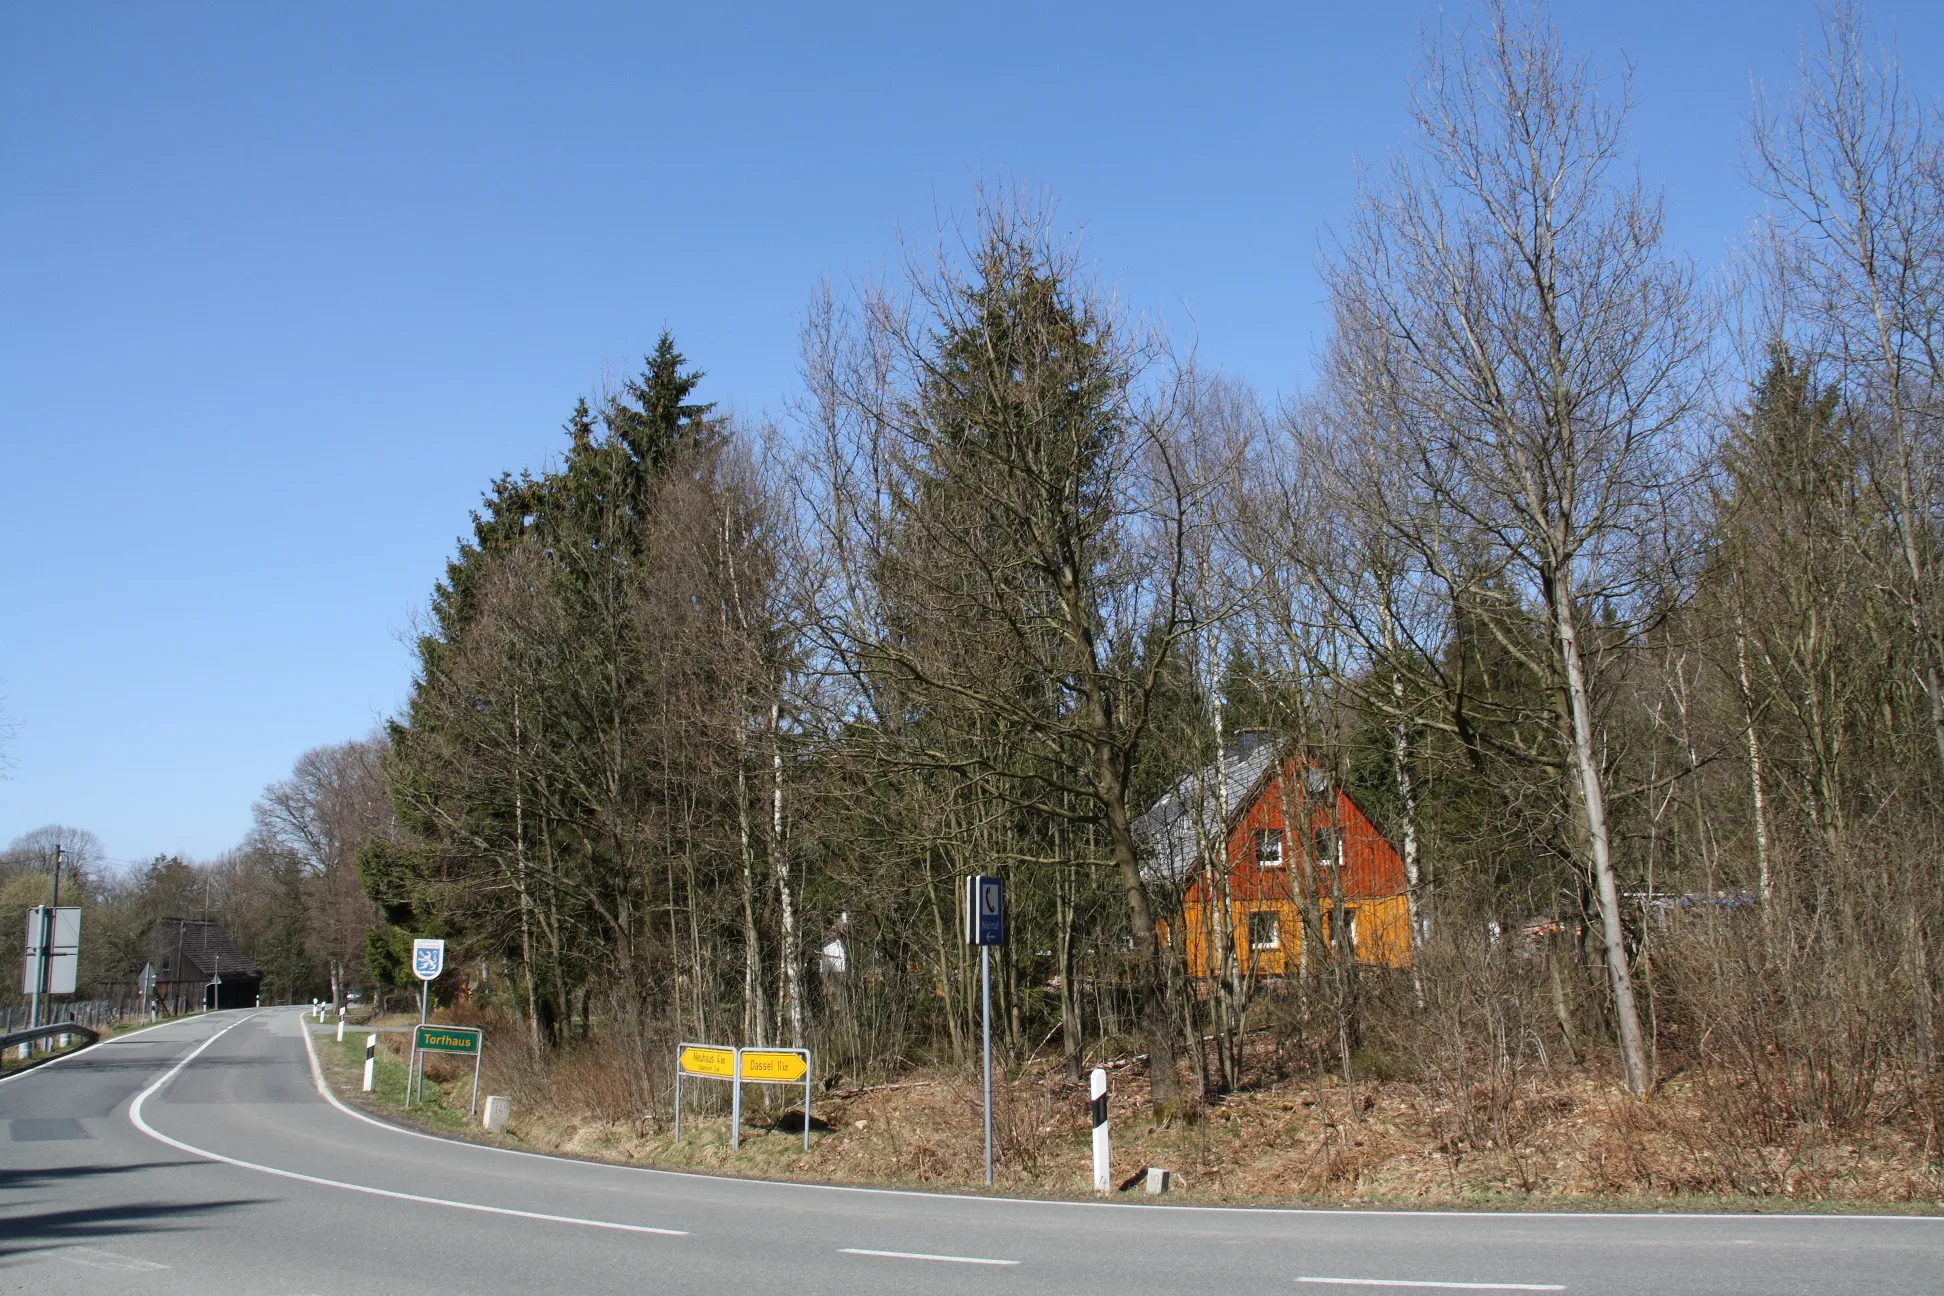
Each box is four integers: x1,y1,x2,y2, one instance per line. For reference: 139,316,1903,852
0,1010,1944,1296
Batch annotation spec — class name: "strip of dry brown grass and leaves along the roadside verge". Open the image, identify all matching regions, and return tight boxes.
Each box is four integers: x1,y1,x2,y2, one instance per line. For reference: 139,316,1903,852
318,1022,1944,1209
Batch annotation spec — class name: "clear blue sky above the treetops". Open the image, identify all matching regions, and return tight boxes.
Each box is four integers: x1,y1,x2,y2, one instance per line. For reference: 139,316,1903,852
0,0,1944,861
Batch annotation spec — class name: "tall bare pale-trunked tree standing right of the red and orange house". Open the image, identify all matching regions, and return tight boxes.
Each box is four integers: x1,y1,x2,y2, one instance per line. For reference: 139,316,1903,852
1326,4,1705,1092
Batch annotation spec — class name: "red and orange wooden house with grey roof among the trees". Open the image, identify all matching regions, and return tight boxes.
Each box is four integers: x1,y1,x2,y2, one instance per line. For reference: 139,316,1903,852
1135,731,1411,977
